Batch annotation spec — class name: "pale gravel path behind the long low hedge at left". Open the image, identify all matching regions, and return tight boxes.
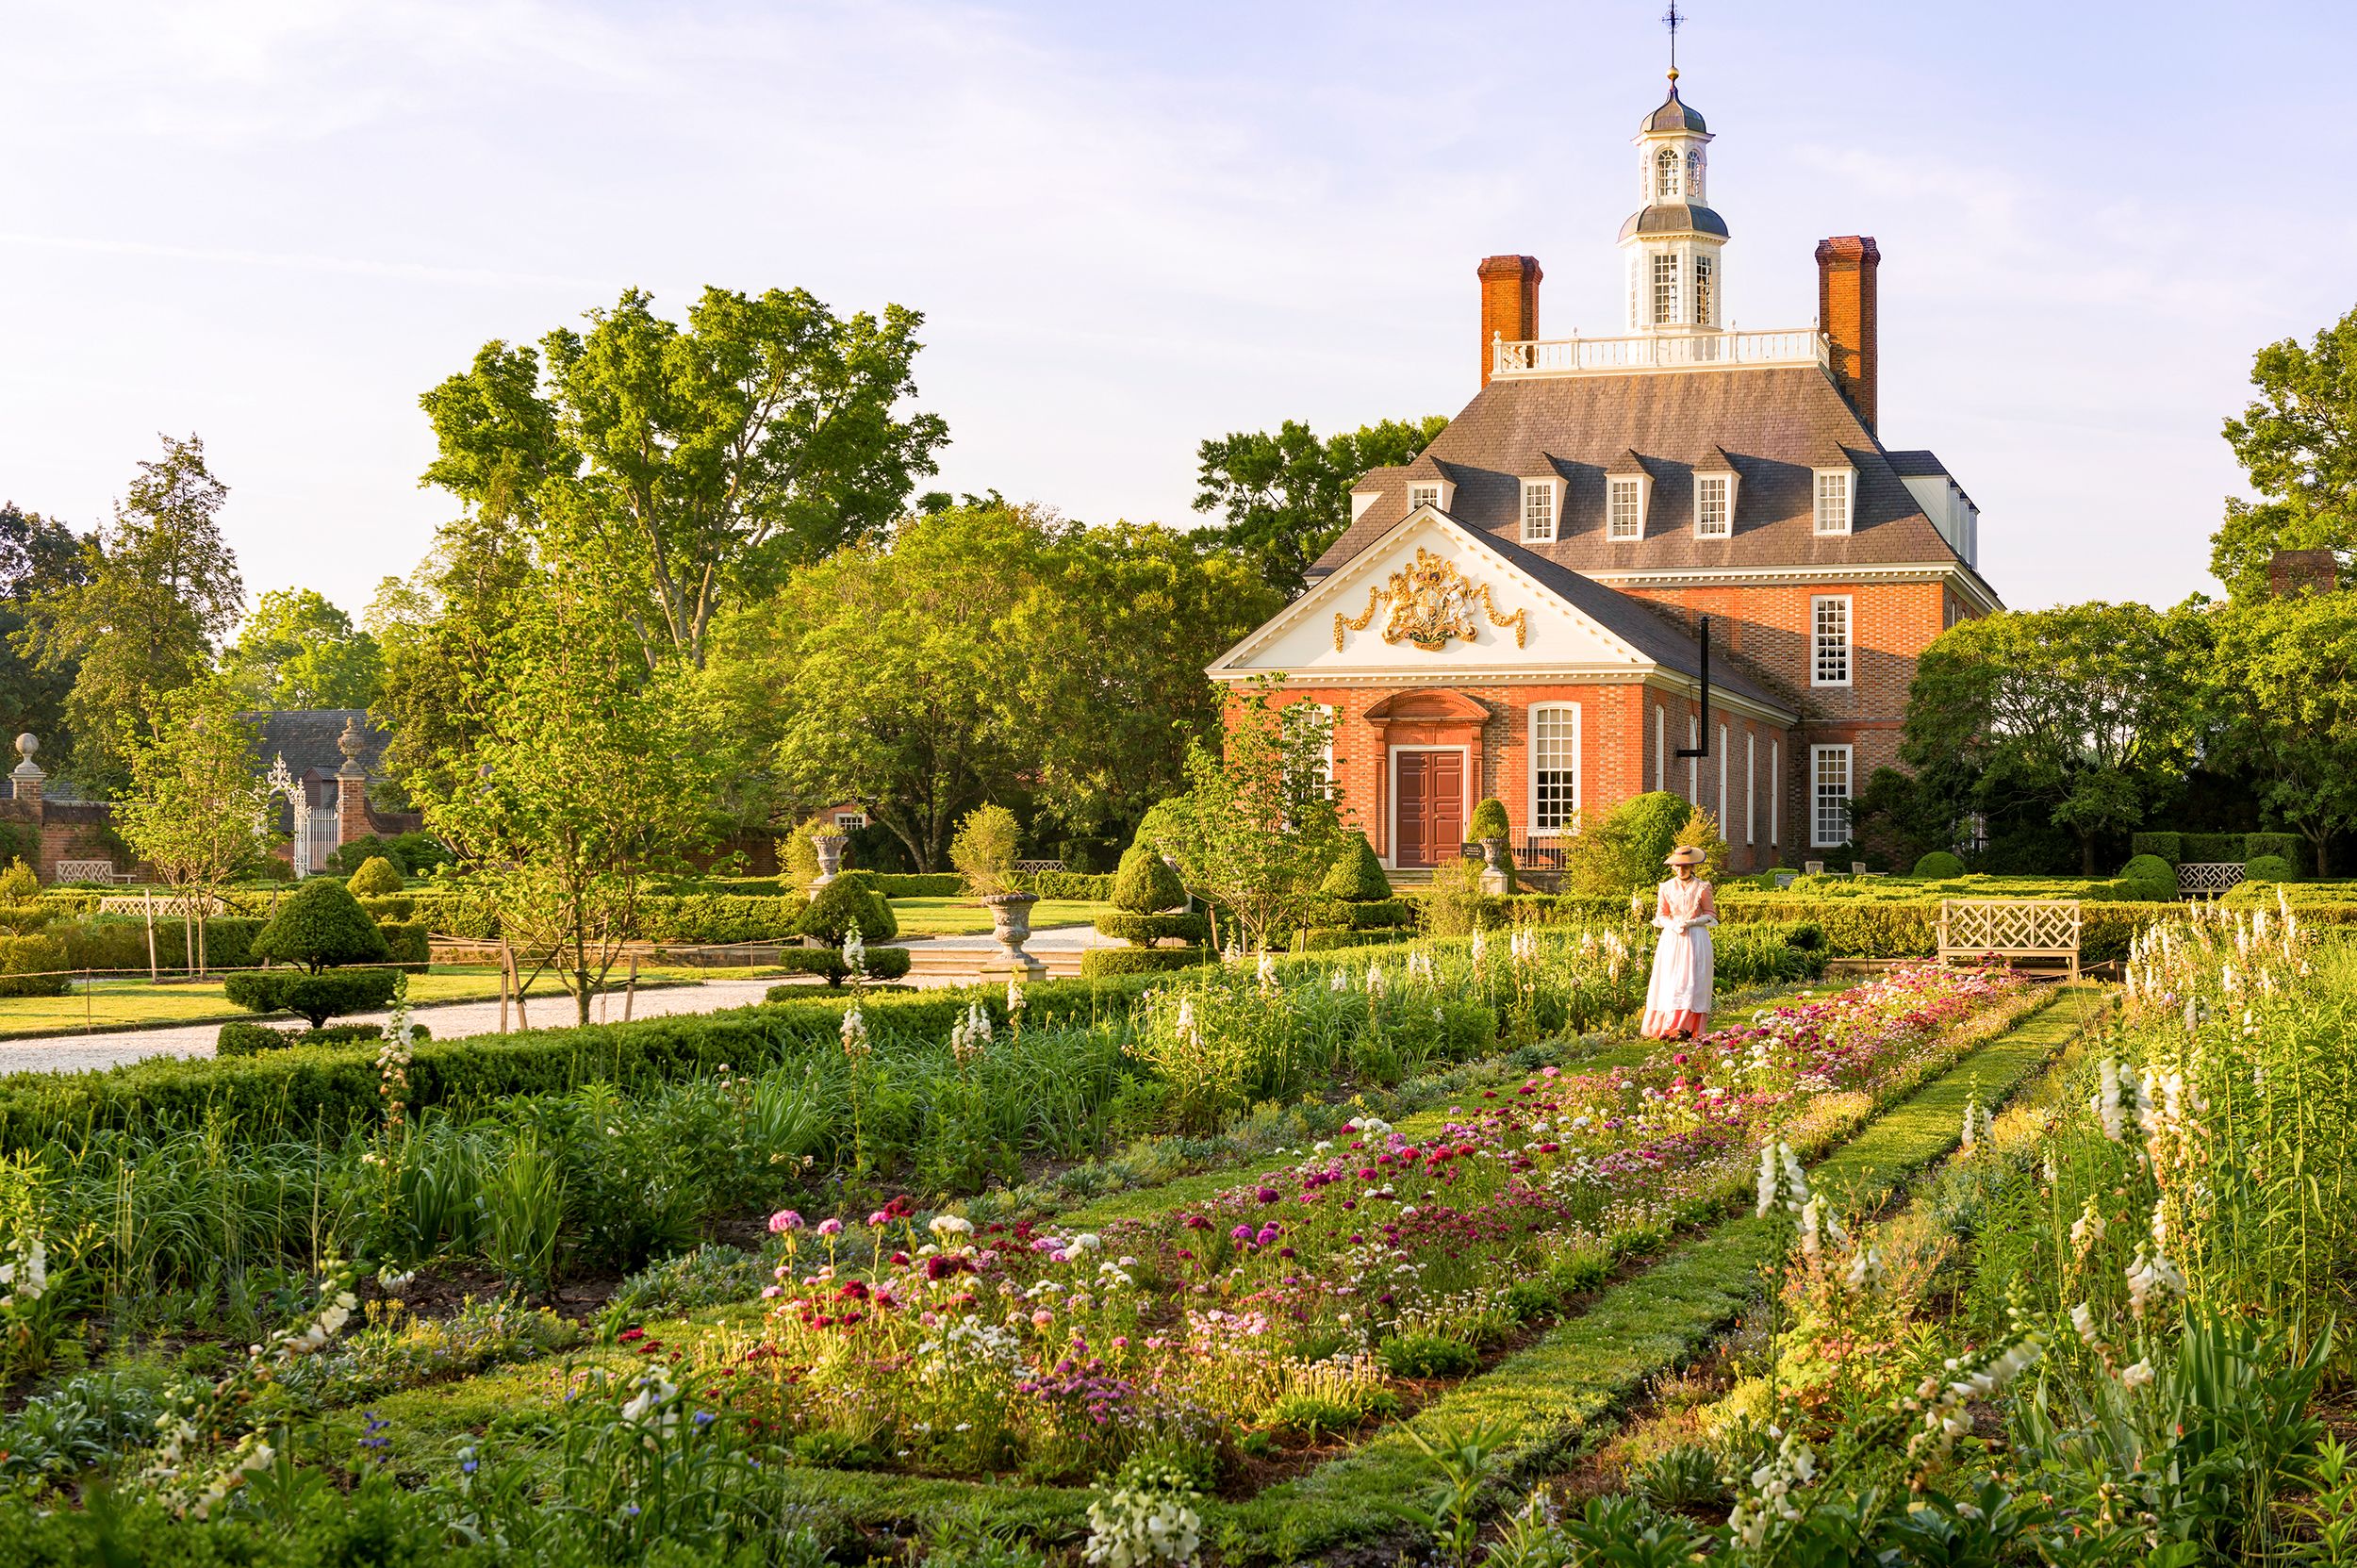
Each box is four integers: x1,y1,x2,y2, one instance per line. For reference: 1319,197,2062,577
0,927,1106,1073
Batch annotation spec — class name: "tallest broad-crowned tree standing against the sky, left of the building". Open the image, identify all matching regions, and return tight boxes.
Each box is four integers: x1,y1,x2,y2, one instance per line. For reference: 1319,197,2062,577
422,288,948,665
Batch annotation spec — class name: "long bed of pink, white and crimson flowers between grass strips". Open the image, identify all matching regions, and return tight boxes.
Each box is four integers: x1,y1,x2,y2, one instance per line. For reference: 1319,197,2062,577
717,969,2020,1478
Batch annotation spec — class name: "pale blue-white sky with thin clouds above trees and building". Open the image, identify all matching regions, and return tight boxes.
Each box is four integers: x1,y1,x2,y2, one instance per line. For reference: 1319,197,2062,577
0,0,2357,613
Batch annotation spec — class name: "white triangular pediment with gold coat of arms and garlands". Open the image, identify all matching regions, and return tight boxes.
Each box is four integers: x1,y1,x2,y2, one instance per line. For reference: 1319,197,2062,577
1211,507,1653,679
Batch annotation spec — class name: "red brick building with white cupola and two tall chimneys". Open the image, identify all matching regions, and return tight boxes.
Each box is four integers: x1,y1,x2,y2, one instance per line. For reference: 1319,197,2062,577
1211,74,1999,870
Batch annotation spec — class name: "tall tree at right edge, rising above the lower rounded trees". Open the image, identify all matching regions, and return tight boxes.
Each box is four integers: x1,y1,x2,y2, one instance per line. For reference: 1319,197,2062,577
2211,311,2357,599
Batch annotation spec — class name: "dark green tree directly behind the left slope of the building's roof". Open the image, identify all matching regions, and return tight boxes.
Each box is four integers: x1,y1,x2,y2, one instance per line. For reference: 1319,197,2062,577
1195,415,1450,599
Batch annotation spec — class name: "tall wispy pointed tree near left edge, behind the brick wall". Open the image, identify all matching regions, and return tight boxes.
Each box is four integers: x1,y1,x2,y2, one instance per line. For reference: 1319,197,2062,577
14,437,245,792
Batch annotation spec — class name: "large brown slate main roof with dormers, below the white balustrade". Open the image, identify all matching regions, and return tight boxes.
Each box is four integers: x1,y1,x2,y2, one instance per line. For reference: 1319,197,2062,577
1310,366,1989,578
